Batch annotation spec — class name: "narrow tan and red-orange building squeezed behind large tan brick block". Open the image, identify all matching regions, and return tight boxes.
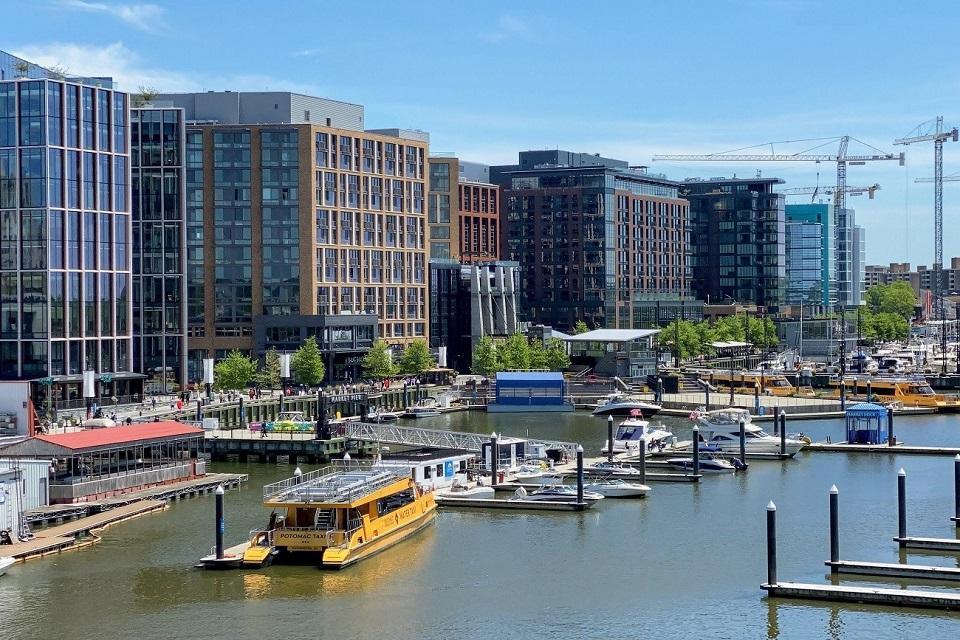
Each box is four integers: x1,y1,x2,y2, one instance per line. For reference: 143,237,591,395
428,154,500,264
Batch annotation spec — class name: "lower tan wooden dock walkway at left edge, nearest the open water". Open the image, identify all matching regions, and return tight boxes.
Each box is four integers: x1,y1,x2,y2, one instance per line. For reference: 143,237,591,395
3,500,167,561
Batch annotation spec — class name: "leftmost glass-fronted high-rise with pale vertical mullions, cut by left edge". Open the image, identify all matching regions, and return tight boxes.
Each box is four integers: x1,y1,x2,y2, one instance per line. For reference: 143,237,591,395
0,72,140,408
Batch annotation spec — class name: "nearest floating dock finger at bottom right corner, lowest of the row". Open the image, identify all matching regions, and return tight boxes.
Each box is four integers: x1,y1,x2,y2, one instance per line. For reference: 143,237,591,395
760,582,960,611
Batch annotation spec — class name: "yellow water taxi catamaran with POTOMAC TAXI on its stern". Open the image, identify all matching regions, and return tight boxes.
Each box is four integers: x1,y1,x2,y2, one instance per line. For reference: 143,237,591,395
243,461,437,569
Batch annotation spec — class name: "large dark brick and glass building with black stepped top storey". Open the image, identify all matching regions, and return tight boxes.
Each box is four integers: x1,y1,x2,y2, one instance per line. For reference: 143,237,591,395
490,150,689,330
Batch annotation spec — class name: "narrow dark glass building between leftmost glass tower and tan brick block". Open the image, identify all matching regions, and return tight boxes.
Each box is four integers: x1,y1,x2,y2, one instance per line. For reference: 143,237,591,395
130,107,186,393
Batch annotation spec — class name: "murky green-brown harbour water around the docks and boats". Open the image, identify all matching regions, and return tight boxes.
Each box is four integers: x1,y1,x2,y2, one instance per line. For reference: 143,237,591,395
0,412,960,640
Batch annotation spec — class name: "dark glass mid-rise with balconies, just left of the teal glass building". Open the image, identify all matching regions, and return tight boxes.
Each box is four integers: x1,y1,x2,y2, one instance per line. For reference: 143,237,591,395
682,178,786,311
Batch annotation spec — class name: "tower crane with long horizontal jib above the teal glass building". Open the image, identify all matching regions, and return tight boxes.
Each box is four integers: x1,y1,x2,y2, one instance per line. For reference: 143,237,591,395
653,136,905,304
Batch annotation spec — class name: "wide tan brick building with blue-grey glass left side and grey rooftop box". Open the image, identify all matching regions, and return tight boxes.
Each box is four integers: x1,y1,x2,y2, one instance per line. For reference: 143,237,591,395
154,92,429,379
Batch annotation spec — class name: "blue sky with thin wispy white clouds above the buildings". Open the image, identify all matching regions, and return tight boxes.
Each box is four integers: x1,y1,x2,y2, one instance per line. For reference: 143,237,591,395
7,0,960,265
